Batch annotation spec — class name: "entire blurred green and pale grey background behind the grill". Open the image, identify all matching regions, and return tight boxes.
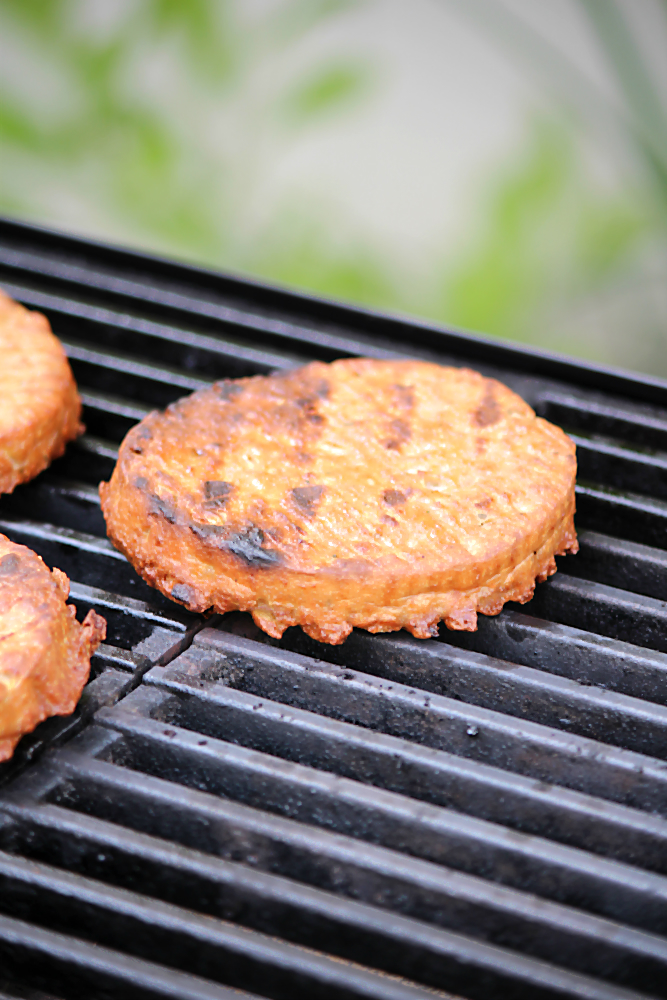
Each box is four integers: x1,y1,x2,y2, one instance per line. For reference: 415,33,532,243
0,0,667,376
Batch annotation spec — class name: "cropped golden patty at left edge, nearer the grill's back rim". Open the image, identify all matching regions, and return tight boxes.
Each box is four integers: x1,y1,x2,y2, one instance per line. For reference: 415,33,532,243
0,291,83,493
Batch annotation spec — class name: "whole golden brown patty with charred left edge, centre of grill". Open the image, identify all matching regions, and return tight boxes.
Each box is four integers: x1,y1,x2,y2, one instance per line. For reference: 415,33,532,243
100,360,577,643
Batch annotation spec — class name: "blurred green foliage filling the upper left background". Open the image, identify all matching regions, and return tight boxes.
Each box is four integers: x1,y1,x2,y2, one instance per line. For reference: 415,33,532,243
0,0,370,270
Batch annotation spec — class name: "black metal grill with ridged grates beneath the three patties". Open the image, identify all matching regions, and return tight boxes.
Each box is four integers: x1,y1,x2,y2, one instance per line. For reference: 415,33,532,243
0,221,667,1000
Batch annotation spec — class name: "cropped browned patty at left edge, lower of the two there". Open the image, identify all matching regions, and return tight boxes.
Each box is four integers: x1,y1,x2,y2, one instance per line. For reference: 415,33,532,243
0,535,106,761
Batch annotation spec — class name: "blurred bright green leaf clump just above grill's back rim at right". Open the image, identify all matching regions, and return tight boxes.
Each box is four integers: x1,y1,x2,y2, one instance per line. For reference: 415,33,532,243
433,121,647,340
